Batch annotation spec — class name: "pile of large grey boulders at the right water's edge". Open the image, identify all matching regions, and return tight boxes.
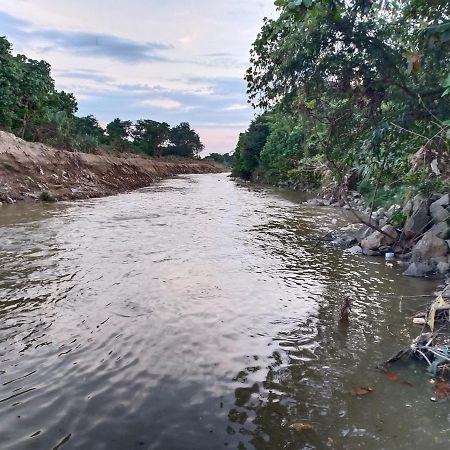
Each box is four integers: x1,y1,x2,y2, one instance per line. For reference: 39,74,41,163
340,194,450,277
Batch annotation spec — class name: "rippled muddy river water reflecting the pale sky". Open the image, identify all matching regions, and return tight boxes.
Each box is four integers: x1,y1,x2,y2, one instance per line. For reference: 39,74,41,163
0,175,450,450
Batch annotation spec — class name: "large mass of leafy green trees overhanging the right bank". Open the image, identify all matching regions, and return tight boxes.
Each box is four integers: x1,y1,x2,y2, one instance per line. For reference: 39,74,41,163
233,0,450,205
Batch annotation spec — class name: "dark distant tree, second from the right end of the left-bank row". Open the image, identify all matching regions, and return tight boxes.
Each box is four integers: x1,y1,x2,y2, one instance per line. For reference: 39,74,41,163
133,120,170,157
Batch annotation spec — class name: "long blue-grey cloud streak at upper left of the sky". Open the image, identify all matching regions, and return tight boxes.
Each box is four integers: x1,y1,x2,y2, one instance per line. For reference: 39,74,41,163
0,12,173,64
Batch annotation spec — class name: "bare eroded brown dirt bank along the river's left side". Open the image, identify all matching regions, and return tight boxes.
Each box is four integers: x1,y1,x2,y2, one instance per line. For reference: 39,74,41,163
0,131,222,203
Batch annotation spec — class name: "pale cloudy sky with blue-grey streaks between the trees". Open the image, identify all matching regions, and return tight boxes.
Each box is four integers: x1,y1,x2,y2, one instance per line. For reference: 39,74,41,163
0,0,275,153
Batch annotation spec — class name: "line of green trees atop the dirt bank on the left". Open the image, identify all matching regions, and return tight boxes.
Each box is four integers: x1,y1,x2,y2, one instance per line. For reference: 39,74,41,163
0,37,204,158
